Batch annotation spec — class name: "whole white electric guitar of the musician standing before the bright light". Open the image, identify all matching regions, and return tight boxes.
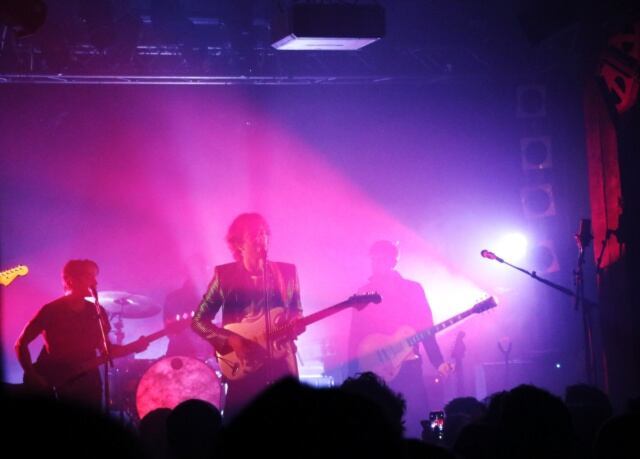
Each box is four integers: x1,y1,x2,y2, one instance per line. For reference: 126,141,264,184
357,297,497,381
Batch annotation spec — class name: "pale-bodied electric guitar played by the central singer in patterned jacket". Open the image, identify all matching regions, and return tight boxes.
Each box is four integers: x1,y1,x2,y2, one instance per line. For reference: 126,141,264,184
216,293,382,381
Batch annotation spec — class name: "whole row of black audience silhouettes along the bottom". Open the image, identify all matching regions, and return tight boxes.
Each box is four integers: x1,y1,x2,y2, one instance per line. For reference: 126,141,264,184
1,372,640,459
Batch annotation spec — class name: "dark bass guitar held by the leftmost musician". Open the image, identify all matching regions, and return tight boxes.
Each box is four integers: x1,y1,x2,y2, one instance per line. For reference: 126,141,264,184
23,318,191,395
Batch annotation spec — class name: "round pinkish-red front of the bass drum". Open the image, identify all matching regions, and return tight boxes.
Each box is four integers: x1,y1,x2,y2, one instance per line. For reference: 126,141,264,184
136,356,222,419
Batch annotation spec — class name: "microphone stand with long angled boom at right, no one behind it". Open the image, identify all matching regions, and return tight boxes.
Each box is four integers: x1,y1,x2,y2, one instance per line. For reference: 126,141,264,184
483,253,597,385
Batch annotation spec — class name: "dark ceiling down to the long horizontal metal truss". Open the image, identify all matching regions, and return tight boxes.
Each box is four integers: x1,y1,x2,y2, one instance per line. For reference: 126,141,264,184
0,0,637,84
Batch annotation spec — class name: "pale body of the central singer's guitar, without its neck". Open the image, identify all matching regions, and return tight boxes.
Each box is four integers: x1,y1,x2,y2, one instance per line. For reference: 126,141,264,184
216,308,296,381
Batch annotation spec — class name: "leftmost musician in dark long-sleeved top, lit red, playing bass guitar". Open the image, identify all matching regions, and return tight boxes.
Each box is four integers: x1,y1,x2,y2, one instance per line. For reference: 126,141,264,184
15,260,148,409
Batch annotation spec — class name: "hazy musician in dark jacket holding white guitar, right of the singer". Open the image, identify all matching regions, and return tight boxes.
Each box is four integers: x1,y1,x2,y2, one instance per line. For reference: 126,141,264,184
349,240,450,438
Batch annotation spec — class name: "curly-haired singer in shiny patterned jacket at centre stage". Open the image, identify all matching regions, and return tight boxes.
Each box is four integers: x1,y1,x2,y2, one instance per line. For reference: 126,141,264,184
193,213,302,419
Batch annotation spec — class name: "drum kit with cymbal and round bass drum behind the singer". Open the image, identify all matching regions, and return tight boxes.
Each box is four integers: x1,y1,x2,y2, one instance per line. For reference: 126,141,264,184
100,291,223,419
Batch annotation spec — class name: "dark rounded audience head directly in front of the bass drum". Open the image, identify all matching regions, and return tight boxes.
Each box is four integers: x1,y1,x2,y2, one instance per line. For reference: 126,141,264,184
167,399,222,459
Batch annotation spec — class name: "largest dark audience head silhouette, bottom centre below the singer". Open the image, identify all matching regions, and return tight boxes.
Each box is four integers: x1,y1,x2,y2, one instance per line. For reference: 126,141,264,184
222,378,403,459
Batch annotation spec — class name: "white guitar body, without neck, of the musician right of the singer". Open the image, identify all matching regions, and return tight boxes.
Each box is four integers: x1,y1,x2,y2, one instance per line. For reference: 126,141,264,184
357,326,416,382
